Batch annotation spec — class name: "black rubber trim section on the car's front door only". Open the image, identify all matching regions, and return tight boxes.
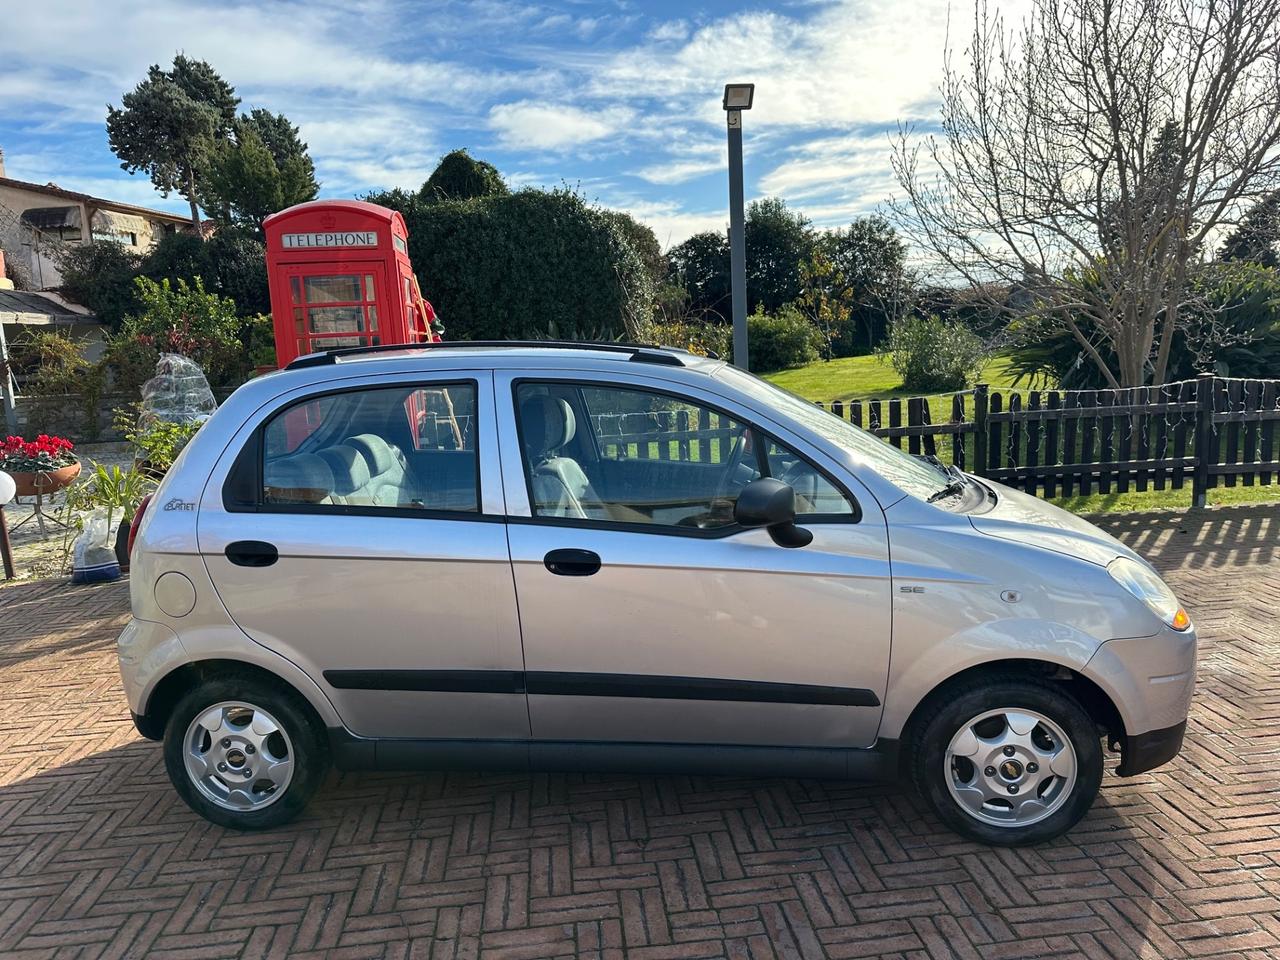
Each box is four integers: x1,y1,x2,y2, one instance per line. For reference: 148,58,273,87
525,672,879,707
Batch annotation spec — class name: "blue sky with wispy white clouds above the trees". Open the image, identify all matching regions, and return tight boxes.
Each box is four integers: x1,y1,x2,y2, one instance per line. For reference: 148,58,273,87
0,0,968,247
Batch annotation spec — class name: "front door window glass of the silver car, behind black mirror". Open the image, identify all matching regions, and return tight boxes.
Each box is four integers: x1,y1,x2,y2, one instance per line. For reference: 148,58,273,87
516,383,854,531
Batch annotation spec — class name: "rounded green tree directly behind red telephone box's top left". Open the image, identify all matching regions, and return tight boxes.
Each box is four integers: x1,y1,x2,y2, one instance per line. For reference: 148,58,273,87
198,110,320,237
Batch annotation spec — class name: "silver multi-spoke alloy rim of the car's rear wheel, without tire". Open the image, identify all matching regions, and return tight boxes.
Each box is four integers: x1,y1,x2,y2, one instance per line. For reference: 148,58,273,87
183,700,293,813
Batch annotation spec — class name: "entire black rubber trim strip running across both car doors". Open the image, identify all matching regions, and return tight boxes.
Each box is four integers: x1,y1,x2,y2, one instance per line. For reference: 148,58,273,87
324,669,879,707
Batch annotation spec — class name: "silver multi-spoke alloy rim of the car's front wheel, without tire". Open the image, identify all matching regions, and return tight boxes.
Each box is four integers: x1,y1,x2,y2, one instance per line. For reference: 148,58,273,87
943,708,1076,827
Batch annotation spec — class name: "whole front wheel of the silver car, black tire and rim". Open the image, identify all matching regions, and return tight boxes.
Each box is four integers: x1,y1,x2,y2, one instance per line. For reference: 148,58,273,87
910,677,1102,846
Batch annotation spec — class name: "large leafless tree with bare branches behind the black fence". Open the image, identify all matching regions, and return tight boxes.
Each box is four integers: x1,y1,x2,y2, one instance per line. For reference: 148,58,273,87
893,0,1280,387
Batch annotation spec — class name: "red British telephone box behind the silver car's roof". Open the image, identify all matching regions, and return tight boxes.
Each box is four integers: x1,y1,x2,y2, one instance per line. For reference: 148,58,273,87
264,200,440,367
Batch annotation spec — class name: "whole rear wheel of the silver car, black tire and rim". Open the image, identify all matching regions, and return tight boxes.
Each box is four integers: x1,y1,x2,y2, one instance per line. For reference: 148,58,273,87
164,675,329,829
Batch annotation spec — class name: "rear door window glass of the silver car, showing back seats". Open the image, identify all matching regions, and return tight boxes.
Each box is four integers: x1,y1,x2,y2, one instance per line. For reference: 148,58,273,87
261,383,480,512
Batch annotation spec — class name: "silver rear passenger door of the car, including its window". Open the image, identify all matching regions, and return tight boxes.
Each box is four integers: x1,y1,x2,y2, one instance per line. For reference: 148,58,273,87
197,370,529,739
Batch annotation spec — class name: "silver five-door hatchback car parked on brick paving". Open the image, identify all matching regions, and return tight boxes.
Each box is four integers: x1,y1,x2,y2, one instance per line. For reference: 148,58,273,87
119,343,1196,845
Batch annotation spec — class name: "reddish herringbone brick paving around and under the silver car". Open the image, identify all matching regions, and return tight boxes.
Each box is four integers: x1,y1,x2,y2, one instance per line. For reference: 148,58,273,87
0,507,1280,960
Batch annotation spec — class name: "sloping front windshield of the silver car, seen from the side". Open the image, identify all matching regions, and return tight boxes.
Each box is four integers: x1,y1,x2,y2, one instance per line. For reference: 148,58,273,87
718,365,951,499
